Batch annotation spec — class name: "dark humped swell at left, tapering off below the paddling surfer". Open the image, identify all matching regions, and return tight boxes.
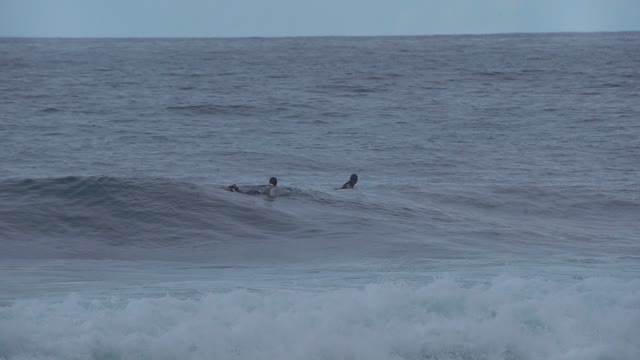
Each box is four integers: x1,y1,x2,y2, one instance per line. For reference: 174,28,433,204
0,176,302,254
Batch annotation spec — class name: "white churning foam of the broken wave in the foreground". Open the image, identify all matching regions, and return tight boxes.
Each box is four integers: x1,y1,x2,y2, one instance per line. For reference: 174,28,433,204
0,277,640,360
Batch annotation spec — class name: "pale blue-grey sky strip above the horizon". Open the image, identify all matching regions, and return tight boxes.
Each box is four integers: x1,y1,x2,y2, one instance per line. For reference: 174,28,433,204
0,0,640,37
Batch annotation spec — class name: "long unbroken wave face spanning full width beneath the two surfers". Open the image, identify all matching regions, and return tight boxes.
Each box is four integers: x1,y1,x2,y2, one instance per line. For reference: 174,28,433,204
0,176,640,261
